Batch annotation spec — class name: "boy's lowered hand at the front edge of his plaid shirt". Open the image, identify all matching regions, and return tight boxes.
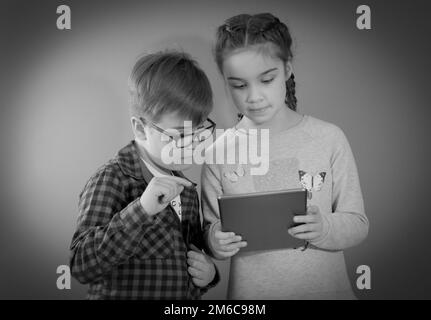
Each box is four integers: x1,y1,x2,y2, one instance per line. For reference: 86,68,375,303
187,245,216,287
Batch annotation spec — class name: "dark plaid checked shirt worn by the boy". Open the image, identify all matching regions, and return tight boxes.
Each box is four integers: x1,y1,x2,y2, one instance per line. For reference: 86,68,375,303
70,141,219,299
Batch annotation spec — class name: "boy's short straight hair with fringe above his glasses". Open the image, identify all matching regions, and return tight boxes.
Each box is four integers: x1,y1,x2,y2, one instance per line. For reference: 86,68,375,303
129,50,213,126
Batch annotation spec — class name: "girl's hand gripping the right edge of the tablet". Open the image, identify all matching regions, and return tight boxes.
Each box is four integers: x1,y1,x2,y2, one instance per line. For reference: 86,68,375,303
288,206,323,241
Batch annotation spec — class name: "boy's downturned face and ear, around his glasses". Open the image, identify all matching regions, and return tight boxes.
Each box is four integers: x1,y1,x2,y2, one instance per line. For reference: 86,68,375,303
132,113,197,171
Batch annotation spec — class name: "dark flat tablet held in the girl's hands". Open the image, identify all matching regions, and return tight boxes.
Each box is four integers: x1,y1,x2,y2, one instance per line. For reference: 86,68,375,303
217,189,307,251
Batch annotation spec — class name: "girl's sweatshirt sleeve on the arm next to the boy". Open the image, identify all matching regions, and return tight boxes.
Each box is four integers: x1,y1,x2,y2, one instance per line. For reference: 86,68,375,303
201,163,224,259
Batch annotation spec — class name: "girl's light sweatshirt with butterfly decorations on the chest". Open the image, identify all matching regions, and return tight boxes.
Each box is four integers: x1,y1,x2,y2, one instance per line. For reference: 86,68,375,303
202,116,369,299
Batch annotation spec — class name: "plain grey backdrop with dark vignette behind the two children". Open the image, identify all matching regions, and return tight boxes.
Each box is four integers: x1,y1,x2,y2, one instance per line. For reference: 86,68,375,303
0,0,431,299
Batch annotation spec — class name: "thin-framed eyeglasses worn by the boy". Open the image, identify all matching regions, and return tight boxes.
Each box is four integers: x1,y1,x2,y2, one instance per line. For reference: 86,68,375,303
139,117,216,148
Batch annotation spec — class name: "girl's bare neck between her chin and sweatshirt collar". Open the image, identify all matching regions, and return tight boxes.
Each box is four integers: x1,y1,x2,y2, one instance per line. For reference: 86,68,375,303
240,107,303,134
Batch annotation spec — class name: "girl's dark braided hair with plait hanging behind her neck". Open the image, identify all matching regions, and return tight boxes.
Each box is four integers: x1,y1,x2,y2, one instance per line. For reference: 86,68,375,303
214,13,297,110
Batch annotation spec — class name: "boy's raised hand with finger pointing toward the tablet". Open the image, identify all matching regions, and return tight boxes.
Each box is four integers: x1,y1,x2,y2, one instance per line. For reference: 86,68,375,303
140,176,192,216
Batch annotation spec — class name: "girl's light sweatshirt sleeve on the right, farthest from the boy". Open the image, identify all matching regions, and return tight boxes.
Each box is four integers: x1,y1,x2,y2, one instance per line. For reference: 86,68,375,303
310,128,369,250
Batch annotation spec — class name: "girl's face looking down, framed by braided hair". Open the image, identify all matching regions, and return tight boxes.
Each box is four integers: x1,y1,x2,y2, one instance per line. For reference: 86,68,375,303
223,50,291,125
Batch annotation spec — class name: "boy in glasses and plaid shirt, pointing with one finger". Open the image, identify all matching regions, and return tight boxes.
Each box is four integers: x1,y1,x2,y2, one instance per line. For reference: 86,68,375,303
70,52,219,299
